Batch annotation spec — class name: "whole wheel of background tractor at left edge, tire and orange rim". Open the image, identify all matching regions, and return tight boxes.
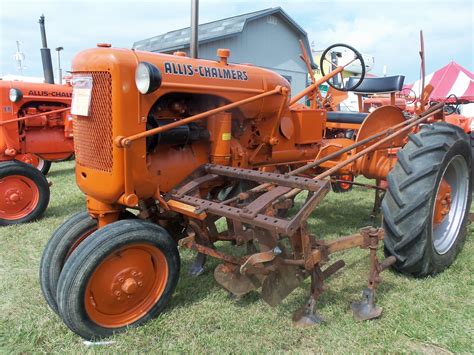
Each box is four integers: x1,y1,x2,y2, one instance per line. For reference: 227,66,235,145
0,161,50,225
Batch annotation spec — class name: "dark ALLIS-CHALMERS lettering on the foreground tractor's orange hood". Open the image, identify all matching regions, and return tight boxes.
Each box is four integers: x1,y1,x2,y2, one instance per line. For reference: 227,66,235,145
164,62,248,81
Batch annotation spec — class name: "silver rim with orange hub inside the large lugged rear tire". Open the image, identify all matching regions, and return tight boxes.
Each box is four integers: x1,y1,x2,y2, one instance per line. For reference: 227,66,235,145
432,155,469,255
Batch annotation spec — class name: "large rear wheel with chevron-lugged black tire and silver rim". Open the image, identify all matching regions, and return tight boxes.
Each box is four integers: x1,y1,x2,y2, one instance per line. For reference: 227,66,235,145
382,123,472,277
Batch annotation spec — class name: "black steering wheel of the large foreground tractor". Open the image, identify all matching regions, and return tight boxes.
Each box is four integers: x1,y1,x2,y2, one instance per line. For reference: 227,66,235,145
319,43,365,91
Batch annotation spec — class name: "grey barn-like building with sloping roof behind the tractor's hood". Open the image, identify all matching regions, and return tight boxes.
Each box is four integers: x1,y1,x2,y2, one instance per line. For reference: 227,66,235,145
133,7,317,97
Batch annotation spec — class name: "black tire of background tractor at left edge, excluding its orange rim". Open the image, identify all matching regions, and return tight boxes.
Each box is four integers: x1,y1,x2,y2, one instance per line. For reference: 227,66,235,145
0,161,50,226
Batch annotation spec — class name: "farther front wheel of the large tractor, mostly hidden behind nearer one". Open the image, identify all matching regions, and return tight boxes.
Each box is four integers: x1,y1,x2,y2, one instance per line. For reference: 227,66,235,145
40,211,136,313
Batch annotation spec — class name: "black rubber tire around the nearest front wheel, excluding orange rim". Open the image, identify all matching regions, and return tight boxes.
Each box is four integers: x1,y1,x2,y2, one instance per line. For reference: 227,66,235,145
56,220,180,339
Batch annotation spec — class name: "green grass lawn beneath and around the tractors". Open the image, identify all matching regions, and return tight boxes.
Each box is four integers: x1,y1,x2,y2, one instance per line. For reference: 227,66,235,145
0,162,474,353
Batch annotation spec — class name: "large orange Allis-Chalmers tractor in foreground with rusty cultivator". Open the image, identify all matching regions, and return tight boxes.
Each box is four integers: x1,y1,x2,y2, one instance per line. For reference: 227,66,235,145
40,44,472,339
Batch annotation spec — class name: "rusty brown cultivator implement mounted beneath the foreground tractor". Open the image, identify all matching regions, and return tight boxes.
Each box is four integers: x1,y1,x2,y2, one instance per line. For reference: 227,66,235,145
168,164,395,326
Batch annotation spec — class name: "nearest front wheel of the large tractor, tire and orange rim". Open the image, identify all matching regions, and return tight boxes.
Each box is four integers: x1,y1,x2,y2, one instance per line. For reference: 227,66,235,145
57,220,180,339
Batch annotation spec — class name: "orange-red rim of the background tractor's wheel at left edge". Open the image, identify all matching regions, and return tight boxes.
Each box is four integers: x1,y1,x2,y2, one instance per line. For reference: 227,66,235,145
0,175,40,220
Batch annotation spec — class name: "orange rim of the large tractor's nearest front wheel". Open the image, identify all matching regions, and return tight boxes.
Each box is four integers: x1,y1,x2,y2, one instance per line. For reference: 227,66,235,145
84,244,168,328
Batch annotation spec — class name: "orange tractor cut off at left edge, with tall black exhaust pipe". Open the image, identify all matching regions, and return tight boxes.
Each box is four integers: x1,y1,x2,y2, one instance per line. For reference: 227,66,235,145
0,17,74,226
